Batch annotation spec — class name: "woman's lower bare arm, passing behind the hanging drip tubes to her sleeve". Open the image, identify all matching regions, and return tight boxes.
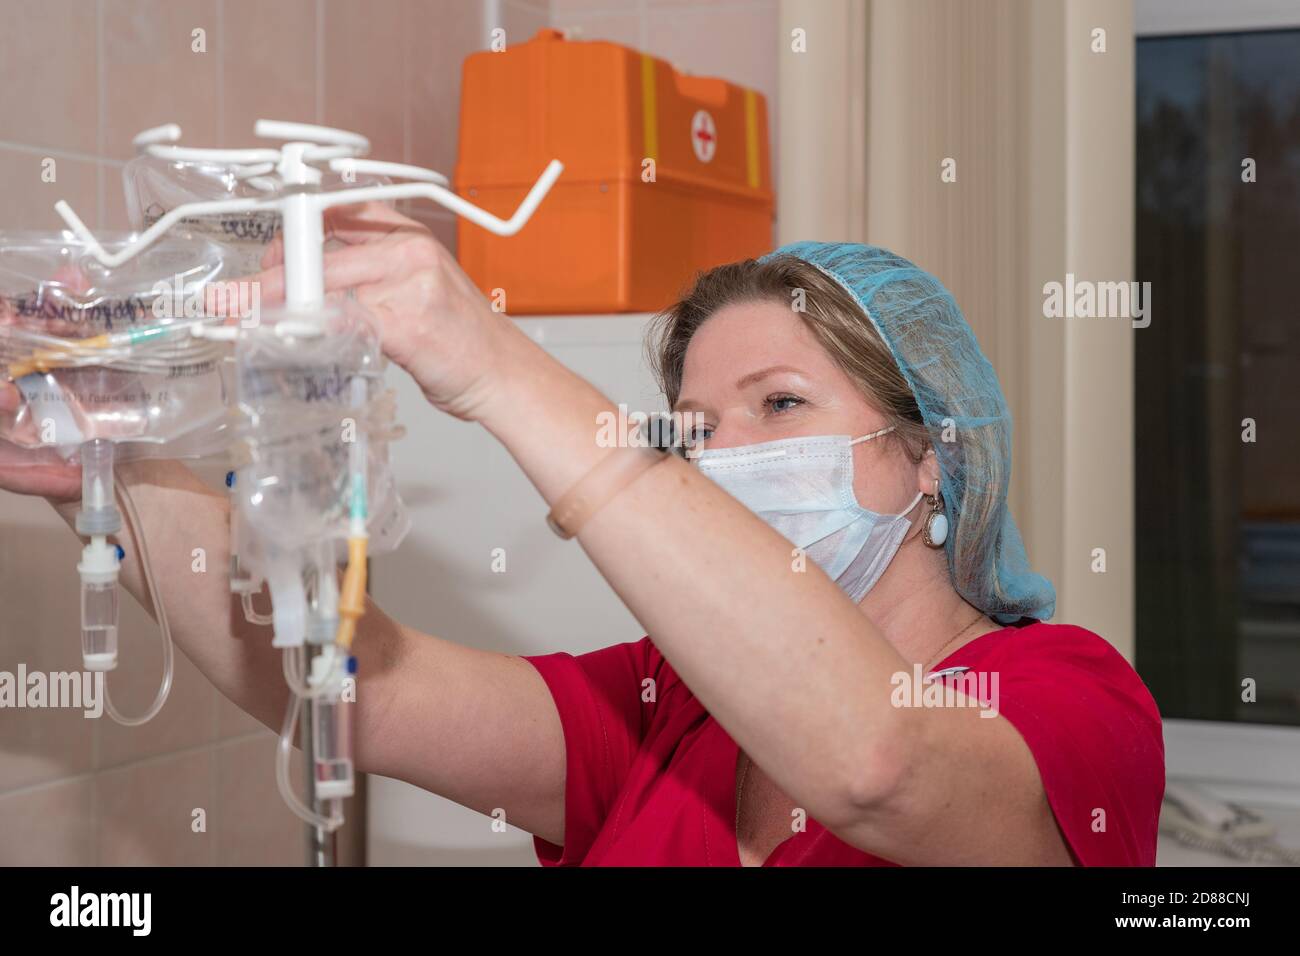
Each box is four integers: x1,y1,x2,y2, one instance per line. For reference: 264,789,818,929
47,462,564,840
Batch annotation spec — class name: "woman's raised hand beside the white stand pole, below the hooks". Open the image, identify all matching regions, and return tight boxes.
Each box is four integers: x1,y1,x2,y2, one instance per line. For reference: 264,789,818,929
244,203,521,420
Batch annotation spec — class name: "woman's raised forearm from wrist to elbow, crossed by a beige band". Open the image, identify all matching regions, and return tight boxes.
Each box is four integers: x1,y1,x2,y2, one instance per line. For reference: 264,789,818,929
481,319,907,823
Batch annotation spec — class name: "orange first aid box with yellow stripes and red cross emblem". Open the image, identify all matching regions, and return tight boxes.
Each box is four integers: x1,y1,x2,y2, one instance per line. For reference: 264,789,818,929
455,30,772,315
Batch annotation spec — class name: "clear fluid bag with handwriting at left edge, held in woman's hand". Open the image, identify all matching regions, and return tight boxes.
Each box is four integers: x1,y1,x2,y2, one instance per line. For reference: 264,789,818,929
0,233,233,463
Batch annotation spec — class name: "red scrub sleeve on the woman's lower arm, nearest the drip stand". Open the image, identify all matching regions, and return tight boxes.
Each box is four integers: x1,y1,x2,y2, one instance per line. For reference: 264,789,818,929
524,637,658,866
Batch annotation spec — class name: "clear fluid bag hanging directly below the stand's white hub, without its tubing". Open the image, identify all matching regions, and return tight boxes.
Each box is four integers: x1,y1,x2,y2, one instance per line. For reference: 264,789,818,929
235,300,410,561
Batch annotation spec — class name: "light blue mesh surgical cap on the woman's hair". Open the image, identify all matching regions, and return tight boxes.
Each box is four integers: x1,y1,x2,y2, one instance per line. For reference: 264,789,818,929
763,242,1056,623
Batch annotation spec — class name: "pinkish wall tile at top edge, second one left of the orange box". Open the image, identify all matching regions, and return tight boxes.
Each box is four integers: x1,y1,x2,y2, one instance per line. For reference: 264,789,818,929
322,0,407,163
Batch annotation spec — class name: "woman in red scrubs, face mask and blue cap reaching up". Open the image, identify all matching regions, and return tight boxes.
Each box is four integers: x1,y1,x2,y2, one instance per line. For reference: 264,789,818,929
0,206,1164,866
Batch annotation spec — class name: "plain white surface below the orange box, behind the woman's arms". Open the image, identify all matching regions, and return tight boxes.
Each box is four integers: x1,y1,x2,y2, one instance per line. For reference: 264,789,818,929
368,315,663,865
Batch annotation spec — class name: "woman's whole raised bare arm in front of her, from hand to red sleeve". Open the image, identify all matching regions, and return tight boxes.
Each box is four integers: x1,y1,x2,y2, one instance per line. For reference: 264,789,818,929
287,206,1063,862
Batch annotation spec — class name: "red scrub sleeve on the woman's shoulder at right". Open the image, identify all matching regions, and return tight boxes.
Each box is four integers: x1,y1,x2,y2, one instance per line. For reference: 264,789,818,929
995,624,1165,866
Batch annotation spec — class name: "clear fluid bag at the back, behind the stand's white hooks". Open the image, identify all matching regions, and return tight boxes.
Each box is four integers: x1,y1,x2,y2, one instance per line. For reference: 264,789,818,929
122,152,389,277
